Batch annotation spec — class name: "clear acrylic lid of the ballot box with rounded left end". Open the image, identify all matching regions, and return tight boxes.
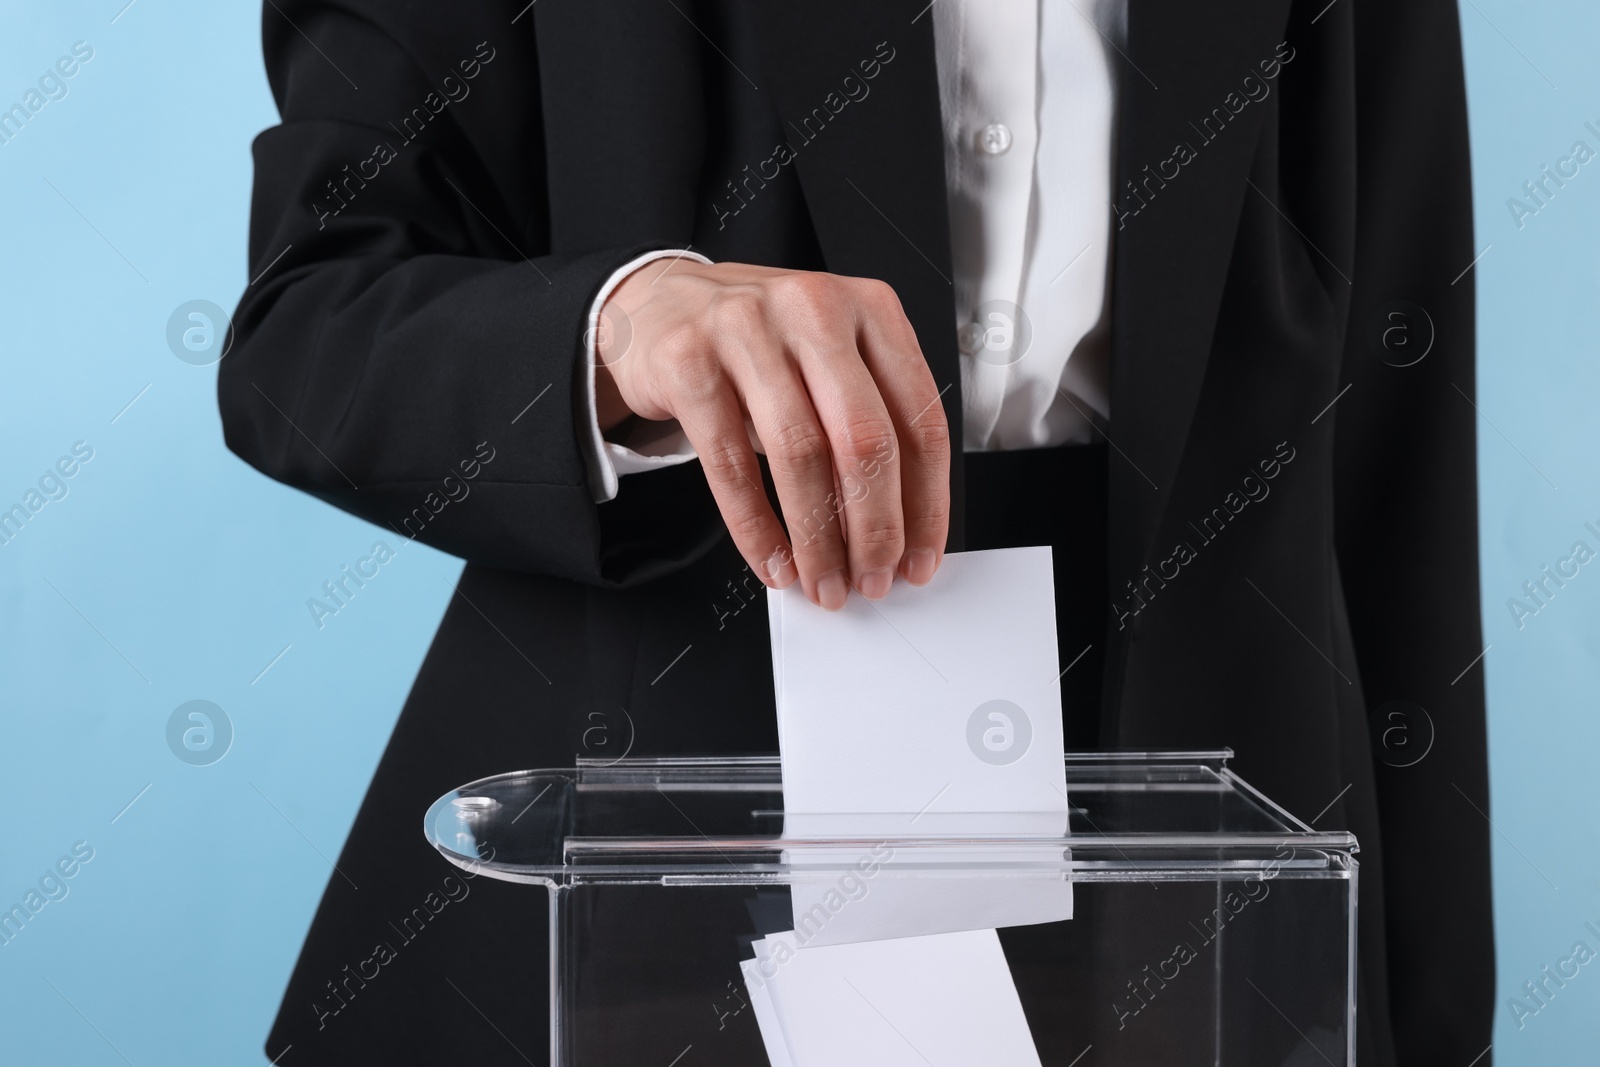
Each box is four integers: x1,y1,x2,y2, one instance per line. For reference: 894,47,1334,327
424,749,1357,886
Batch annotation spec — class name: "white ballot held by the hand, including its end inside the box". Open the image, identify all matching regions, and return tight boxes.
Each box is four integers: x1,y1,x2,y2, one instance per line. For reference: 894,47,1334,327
768,547,1072,945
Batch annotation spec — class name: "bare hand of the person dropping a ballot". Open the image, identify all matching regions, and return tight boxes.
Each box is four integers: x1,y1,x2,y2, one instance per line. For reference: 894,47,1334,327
595,261,950,611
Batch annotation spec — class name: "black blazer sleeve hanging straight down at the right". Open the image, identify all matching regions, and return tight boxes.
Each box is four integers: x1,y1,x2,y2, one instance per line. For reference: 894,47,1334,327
1312,0,1494,1043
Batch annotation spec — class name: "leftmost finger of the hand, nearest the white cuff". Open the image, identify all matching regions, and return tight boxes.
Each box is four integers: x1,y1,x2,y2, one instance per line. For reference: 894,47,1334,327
652,329,798,589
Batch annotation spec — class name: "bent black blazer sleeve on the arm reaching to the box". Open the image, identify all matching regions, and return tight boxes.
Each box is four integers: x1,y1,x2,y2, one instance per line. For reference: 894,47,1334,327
218,0,723,584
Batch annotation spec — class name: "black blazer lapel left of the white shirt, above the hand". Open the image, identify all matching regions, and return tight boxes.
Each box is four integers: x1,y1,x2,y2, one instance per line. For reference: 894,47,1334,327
757,0,965,549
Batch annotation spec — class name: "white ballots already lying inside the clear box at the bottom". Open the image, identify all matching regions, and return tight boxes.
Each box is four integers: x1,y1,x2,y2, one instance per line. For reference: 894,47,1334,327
742,929,1040,1067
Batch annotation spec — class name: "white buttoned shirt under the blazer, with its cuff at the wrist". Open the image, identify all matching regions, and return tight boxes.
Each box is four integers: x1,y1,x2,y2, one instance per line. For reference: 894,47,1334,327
586,0,1126,502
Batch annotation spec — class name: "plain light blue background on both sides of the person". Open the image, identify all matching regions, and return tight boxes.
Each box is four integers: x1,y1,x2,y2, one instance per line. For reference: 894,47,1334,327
0,0,1600,1067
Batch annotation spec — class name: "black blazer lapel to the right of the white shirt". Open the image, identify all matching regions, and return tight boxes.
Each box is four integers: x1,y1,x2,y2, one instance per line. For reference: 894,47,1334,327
1113,0,1290,585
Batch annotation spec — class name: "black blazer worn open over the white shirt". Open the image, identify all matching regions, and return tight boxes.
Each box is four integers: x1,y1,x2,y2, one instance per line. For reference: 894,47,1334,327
219,0,1493,1064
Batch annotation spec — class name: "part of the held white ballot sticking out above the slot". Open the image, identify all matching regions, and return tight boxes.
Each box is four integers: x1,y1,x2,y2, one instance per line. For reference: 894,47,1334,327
768,547,1067,833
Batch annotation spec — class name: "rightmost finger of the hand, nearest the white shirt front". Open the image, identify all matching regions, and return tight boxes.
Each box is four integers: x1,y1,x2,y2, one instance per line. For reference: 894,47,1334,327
856,280,950,585
